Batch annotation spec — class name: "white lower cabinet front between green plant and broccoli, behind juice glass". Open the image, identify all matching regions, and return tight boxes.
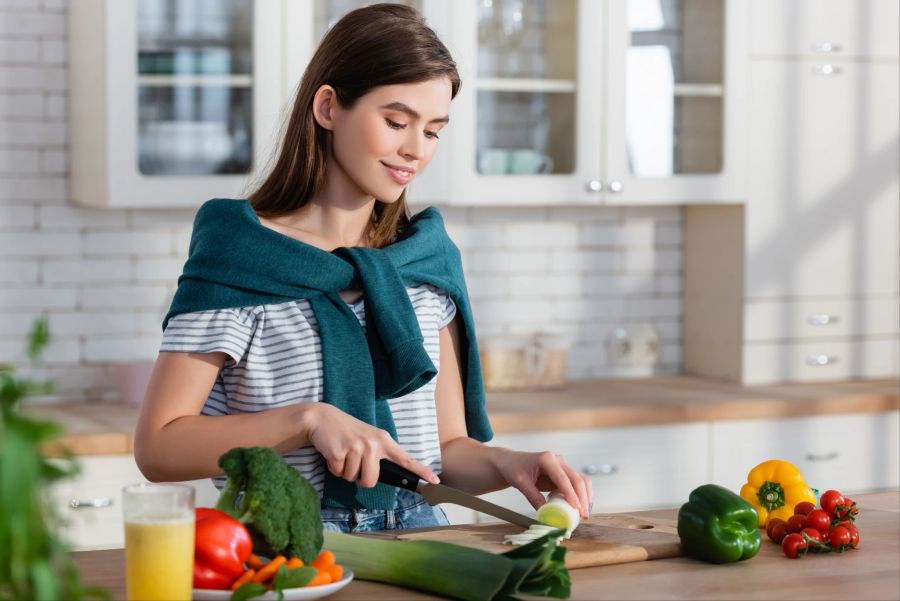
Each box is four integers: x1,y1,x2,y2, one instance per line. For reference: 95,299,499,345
48,455,218,551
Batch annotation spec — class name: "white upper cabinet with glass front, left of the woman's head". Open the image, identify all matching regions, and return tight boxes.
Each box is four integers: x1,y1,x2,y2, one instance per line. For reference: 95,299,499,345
69,0,284,208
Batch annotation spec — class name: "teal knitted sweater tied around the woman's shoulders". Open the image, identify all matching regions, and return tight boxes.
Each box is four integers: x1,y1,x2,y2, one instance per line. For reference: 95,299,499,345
163,198,493,509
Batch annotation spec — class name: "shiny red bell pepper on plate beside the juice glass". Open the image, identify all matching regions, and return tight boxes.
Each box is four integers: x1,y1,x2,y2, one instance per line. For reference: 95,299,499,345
194,507,253,589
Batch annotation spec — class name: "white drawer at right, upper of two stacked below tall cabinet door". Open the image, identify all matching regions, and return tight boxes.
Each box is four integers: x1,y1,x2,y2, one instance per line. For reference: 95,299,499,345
744,296,900,342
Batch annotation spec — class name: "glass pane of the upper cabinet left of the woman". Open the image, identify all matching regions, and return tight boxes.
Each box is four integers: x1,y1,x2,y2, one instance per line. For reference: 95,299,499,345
136,0,256,176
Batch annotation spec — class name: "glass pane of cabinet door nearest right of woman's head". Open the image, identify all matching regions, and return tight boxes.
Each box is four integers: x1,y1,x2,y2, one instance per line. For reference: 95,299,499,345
473,0,579,176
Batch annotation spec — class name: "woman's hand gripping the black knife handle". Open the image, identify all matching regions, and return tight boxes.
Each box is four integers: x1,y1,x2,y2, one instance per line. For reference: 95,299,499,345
307,402,440,488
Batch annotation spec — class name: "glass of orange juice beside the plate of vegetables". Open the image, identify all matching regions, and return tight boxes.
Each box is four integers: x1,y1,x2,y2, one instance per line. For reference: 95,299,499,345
122,482,194,601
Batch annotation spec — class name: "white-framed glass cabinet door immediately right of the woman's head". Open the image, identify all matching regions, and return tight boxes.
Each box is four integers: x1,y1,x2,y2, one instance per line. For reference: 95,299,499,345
438,0,606,205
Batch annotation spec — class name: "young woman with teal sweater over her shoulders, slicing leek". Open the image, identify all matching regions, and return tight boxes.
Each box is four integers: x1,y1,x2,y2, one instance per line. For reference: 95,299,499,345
135,4,593,531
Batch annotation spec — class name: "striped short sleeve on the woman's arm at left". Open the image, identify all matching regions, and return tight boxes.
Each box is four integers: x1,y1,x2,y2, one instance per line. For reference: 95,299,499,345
159,307,256,367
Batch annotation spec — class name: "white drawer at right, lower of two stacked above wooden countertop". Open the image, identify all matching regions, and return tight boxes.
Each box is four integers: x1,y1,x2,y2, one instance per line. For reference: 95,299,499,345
743,338,900,385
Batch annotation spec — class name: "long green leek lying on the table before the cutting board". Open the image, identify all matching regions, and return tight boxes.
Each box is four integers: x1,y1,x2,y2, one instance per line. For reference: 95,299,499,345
325,529,571,601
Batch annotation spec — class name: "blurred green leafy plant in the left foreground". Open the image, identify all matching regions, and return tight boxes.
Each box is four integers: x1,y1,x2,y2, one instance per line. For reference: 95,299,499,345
0,317,109,601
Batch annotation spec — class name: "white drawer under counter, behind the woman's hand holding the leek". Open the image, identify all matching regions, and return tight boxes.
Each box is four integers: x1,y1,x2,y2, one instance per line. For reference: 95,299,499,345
478,423,709,521
